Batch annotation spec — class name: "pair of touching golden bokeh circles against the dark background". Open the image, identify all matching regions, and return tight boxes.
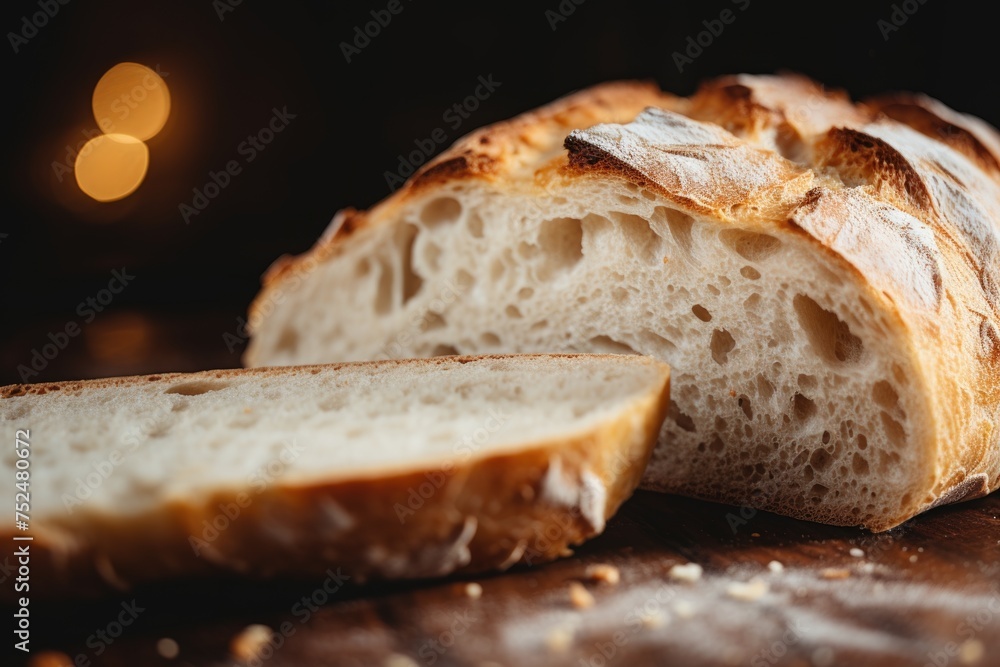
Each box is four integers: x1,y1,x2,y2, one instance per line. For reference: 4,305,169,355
74,63,170,201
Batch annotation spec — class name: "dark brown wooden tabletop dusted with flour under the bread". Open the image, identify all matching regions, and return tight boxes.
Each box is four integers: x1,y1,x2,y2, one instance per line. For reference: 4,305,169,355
17,492,1000,667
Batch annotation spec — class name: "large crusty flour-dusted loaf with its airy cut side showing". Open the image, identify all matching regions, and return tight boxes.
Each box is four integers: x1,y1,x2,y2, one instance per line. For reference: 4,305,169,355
246,76,1000,530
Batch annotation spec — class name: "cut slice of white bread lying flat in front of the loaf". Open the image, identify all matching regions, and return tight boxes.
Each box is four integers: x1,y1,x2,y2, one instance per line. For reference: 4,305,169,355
0,355,669,594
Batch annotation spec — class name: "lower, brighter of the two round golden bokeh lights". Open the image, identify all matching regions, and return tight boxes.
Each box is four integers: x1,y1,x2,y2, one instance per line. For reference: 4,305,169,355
74,134,149,202
